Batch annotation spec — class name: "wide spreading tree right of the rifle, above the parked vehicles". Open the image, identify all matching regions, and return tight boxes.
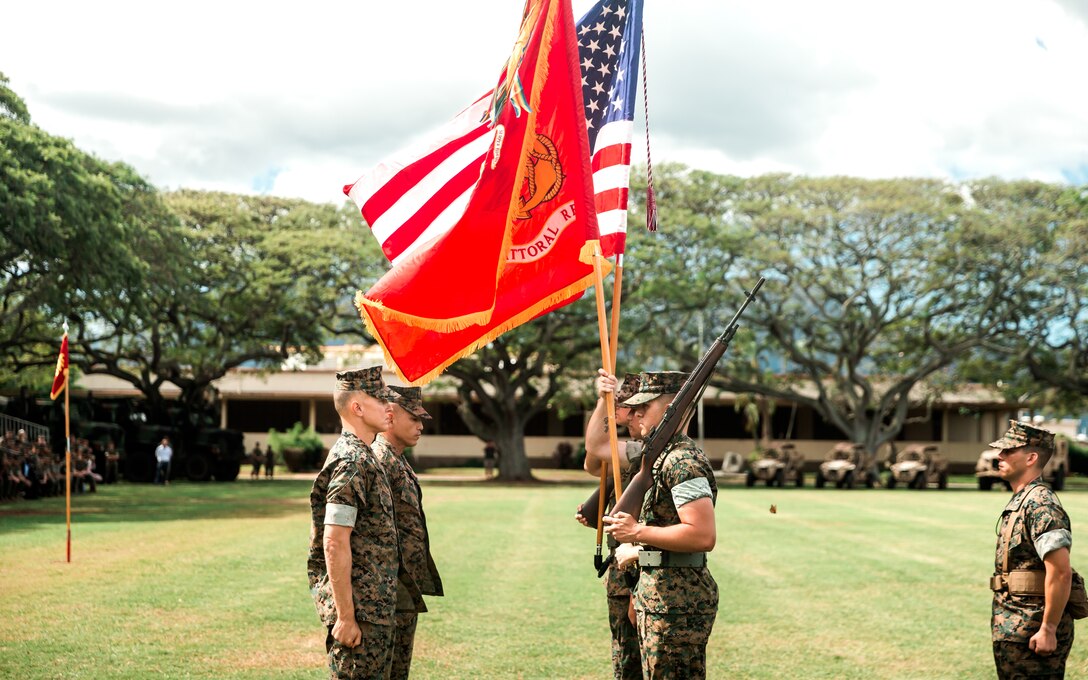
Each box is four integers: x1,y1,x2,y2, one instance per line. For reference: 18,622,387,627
631,173,1037,452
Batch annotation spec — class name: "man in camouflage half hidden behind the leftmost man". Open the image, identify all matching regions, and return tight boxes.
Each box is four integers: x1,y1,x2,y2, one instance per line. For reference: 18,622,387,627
374,386,444,680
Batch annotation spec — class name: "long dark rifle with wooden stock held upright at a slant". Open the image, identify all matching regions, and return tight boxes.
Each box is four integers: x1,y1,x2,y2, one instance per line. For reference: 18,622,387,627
582,276,764,541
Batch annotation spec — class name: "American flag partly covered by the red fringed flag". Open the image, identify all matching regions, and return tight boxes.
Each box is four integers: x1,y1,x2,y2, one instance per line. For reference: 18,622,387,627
344,0,642,264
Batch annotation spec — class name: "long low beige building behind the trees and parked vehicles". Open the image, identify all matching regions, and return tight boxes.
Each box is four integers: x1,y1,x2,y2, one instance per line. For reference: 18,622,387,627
76,345,1018,472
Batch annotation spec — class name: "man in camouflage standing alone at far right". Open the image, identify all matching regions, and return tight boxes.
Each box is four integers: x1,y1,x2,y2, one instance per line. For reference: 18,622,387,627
990,421,1073,680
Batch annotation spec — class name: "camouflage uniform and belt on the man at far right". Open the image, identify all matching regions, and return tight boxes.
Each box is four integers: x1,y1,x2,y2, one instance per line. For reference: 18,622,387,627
990,479,1073,679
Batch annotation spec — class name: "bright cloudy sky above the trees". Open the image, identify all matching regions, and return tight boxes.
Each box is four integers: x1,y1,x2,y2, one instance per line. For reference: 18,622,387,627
0,0,1088,201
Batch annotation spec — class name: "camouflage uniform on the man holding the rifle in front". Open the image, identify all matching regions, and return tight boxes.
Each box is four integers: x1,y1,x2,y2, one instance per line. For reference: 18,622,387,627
634,434,718,680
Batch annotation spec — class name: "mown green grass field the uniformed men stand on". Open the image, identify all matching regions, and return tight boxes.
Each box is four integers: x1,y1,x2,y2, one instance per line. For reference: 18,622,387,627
0,479,1088,680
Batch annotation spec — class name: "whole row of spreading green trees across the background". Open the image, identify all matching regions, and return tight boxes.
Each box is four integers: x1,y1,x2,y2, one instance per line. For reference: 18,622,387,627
0,63,1088,472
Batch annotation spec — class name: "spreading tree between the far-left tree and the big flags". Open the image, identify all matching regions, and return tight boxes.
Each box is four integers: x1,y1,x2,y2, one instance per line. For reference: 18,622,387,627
62,191,375,409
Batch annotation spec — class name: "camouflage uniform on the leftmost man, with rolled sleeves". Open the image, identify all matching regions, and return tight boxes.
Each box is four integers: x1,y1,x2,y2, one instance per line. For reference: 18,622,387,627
307,432,399,679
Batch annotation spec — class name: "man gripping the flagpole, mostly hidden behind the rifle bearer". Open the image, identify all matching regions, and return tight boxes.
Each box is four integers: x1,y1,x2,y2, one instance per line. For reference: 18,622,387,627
580,371,642,680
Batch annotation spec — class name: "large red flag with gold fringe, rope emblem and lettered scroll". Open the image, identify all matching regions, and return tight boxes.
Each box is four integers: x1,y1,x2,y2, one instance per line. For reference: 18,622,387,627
356,0,599,384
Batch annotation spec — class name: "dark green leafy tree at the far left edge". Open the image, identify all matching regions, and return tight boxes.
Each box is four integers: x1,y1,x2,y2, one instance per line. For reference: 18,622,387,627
0,74,166,363
